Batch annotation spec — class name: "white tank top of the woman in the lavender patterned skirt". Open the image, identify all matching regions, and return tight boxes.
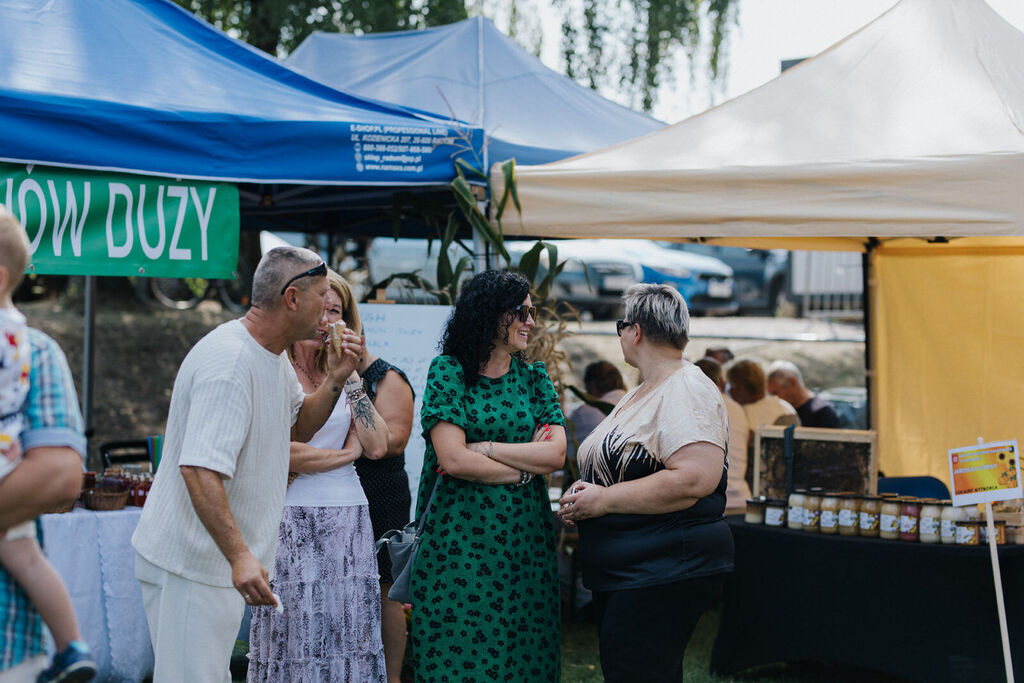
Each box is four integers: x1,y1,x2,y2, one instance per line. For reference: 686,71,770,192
285,392,367,508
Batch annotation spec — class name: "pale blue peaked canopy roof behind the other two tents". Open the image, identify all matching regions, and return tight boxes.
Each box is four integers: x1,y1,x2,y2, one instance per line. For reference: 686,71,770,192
287,16,665,164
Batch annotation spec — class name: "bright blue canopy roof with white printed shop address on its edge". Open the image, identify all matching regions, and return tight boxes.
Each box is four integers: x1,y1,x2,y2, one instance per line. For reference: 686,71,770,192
0,0,482,186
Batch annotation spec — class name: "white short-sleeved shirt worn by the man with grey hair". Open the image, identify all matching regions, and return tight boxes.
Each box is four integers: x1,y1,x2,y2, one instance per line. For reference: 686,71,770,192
132,321,305,588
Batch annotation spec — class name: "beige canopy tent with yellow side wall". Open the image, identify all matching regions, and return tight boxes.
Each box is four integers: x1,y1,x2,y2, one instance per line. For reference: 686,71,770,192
492,0,1024,480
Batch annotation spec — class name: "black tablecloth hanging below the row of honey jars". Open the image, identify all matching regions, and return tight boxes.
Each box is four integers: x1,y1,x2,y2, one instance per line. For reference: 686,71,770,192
711,516,1024,681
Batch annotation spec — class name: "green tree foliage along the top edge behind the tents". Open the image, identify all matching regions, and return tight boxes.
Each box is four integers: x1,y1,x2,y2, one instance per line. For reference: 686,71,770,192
175,0,739,112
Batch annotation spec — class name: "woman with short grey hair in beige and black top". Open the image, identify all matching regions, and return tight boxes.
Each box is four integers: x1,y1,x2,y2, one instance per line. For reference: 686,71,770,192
560,284,733,683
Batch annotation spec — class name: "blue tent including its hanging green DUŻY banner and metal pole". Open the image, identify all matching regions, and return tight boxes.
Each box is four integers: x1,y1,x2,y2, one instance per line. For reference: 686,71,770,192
0,0,483,436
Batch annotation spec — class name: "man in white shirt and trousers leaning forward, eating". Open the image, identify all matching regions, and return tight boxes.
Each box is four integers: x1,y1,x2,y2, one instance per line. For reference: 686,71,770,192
132,247,361,683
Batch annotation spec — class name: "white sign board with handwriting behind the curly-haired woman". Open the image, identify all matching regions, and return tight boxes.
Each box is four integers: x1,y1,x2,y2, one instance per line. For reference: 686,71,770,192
359,303,452,510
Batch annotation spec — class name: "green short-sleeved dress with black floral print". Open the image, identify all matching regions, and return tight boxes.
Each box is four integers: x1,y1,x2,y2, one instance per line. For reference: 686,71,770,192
412,355,565,683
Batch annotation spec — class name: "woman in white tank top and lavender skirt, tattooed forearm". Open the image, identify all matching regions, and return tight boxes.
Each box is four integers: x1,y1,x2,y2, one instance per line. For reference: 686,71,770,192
248,270,388,683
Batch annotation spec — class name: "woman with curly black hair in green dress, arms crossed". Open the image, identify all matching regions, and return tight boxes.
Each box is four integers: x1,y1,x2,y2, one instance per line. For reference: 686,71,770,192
412,270,565,682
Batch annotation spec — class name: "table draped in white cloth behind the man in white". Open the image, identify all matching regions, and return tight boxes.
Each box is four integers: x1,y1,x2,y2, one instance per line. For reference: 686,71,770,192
42,508,153,681
